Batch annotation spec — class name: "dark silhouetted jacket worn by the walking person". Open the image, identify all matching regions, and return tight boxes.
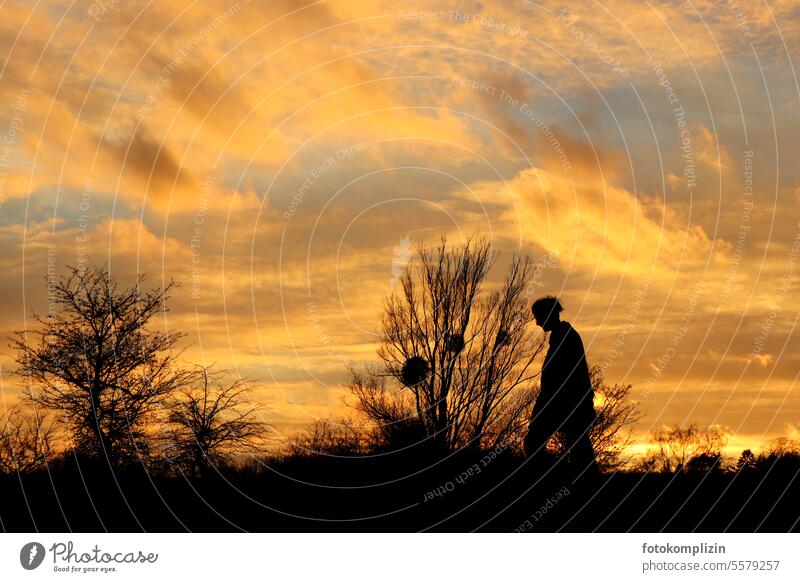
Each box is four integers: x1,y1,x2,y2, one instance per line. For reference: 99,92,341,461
533,321,595,430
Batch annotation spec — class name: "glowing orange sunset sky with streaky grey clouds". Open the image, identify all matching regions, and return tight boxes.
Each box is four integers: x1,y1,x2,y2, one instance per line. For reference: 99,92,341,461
0,0,800,452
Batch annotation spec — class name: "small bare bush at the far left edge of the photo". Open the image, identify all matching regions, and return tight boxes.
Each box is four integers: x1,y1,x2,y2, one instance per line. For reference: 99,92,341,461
0,404,56,474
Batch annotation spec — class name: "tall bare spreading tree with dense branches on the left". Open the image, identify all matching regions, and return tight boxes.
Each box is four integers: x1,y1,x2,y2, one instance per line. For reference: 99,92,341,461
11,266,195,465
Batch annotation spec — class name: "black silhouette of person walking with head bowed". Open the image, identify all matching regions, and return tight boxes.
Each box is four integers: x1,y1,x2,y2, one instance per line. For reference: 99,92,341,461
525,296,597,474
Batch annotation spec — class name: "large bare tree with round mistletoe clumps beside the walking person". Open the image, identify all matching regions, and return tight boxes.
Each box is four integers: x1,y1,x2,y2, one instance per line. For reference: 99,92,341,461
368,238,543,450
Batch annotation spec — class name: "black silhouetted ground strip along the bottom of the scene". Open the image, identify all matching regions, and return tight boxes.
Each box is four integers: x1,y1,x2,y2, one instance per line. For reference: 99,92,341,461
0,452,800,532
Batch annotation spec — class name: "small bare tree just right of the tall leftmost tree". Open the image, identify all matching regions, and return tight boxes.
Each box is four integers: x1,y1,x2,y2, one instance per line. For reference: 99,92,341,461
168,366,267,476
